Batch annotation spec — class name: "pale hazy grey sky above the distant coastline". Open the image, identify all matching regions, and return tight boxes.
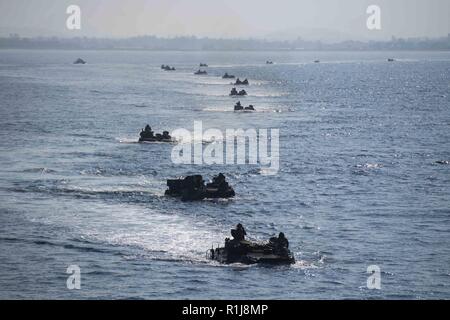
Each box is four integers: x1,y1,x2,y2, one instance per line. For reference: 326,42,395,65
0,0,450,40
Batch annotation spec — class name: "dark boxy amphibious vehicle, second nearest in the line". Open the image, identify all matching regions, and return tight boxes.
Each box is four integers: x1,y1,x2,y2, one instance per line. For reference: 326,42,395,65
165,173,236,201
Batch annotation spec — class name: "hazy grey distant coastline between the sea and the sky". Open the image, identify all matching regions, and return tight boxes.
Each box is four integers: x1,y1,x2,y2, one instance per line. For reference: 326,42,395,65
0,34,450,51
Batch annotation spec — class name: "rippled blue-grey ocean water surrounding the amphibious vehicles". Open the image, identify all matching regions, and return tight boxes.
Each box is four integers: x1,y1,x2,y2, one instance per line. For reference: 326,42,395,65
0,50,450,299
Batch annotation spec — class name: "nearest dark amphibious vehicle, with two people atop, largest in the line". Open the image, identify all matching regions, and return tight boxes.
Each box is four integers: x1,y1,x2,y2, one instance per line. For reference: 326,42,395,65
207,224,295,265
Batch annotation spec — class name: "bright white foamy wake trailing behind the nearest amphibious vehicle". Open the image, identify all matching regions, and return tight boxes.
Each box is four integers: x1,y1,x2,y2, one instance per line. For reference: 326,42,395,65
67,205,225,262
